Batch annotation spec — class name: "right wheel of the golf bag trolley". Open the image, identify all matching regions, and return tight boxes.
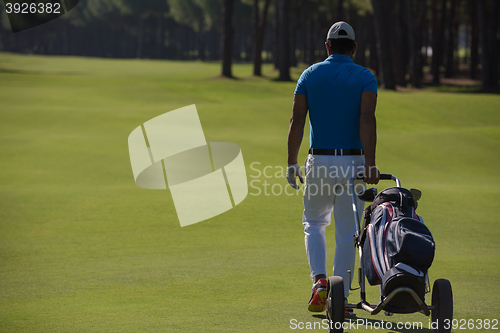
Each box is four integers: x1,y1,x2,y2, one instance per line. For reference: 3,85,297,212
432,279,453,333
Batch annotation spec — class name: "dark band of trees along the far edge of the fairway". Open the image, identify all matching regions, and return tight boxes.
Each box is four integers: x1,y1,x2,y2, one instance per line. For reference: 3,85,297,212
0,0,500,89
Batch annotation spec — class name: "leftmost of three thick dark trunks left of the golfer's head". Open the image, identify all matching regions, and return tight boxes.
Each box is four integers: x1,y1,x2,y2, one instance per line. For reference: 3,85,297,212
221,0,234,77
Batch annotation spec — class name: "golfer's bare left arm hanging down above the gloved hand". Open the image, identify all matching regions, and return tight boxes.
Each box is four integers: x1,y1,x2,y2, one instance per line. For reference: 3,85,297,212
287,95,307,165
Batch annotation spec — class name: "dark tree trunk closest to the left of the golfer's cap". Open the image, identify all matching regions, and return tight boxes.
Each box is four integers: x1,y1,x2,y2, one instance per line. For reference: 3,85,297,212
278,0,291,81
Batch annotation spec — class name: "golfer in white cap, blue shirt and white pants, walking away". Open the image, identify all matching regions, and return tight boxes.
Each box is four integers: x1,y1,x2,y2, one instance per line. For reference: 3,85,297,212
287,22,380,316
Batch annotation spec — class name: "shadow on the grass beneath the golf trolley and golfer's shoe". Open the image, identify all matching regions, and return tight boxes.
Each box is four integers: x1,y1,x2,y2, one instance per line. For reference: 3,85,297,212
313,314,434,333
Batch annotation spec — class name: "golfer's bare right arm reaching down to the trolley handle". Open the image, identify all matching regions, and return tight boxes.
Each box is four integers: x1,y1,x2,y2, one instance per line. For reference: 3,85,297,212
359,91,380,184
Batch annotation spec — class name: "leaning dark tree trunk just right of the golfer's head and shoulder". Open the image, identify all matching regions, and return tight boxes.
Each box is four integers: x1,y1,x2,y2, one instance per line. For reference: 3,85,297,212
372,0,396,90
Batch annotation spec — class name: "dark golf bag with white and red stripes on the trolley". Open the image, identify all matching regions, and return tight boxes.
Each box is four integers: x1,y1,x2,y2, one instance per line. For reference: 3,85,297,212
360,187,435,313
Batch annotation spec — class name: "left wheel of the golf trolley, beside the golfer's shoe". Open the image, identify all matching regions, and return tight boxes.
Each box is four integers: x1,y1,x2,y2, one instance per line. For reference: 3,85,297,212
326,276,345,333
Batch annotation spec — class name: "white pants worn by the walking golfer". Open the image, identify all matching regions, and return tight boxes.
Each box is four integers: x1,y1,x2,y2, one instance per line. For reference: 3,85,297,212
302,155,364,297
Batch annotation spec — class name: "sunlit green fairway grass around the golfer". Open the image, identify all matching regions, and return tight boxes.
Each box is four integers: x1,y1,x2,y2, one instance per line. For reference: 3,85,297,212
0,54,500,332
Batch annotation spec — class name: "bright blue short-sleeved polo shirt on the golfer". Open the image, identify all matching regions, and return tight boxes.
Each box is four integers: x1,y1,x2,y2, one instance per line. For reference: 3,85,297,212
295,54,378,149
